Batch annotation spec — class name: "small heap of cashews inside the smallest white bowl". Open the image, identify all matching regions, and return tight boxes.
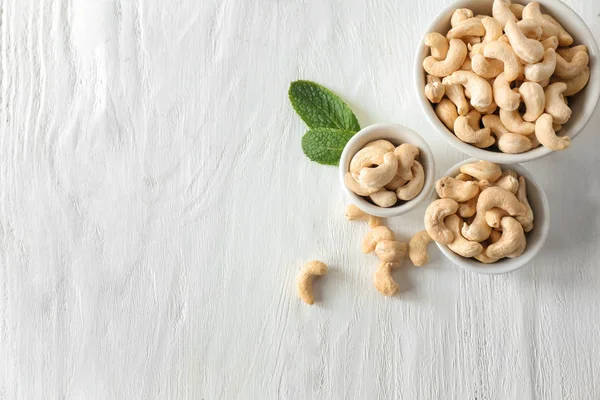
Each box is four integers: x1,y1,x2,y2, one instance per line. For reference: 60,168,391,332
345,140,425,207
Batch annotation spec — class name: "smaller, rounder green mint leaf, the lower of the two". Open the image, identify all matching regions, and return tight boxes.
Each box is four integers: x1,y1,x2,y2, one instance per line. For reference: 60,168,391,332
302,128,354,165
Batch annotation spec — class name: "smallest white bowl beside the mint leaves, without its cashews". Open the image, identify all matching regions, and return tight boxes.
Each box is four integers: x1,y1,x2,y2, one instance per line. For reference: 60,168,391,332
339,123,435,218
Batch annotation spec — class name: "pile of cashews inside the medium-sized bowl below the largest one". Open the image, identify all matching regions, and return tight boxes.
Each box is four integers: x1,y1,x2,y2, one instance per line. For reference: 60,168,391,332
425,161,533,264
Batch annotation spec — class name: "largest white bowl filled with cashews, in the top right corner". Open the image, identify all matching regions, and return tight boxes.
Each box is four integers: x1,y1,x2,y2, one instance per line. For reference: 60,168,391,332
415,0,600,164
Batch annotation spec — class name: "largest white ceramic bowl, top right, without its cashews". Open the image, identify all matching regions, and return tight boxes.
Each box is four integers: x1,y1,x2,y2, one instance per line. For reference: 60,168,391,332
414,0,600,164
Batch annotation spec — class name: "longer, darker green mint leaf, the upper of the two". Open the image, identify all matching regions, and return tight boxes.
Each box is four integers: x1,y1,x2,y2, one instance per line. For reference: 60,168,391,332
288,81,360,132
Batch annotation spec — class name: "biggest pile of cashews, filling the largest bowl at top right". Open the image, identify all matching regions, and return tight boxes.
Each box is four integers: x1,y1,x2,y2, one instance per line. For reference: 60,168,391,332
423,0,590,154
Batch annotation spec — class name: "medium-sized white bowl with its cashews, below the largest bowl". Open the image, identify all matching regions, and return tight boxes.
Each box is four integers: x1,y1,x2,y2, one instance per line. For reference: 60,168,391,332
424,159,550,275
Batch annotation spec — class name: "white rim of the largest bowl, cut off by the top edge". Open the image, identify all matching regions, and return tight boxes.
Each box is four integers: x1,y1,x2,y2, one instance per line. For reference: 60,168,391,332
414,0,600,164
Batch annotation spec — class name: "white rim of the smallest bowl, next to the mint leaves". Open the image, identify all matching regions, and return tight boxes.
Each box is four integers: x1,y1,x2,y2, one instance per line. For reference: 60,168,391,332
338,122,435,218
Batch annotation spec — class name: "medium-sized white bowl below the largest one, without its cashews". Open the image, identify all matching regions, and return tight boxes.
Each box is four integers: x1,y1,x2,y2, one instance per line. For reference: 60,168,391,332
433,158,550,275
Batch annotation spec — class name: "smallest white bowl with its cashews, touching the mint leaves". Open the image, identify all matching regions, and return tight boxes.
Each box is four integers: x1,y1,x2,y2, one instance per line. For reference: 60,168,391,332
339,123,435,217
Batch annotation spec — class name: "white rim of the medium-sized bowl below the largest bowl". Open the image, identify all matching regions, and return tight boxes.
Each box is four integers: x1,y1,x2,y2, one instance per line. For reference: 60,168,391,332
432,158,550,275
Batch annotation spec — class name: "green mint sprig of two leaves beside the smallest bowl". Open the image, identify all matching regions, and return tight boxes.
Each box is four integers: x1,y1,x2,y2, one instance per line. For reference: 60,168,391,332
288,81,360,165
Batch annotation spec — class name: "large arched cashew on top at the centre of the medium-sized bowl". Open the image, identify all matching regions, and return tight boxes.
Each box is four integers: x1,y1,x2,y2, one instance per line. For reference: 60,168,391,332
461,186,525,242
